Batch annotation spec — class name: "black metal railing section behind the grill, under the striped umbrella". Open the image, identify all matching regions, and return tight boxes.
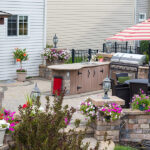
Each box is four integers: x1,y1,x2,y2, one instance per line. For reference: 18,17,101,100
102,42,141,54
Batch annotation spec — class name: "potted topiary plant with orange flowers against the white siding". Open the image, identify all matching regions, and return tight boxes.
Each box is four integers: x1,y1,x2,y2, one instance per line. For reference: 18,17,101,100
13,48,28,82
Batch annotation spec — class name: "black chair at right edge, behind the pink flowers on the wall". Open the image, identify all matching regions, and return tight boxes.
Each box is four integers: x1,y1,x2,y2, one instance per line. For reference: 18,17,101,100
130,82,148,100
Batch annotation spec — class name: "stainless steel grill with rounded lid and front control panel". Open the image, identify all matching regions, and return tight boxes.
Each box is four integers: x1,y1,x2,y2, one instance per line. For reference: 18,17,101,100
110,53,146,78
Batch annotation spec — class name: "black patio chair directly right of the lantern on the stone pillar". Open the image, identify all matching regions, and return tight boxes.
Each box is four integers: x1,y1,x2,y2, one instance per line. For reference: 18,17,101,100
111,79,130,108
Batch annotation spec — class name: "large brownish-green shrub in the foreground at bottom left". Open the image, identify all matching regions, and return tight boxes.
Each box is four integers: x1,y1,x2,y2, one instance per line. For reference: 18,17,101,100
9,92,98,150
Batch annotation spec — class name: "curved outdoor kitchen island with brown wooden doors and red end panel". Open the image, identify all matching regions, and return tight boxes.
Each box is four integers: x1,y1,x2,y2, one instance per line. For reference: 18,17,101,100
48,62,109,95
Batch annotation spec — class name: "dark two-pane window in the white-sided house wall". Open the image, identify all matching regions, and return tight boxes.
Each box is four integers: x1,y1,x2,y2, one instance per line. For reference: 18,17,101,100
8,15,28,36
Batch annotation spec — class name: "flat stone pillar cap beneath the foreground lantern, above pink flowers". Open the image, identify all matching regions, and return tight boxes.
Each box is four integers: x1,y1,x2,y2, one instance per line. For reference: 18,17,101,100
89,94,125,106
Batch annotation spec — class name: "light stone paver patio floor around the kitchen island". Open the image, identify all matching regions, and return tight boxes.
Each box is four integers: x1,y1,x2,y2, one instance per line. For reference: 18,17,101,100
0,78,103,147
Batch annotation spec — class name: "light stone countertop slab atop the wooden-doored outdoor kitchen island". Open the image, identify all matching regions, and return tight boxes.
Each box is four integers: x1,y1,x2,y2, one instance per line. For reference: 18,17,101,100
48,62,110,70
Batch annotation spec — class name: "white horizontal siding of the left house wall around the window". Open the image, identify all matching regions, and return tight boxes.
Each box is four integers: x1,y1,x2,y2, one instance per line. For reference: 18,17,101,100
0,0,45,80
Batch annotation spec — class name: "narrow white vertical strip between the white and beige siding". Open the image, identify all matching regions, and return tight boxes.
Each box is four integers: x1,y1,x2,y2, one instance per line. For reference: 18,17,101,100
44,0,47,48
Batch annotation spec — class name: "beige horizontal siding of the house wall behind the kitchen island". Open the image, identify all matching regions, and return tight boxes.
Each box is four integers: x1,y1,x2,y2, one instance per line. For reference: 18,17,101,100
47,0,135,49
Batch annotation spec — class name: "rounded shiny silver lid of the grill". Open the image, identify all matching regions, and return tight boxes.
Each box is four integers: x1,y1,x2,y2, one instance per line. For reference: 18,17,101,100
111,53,146,65
